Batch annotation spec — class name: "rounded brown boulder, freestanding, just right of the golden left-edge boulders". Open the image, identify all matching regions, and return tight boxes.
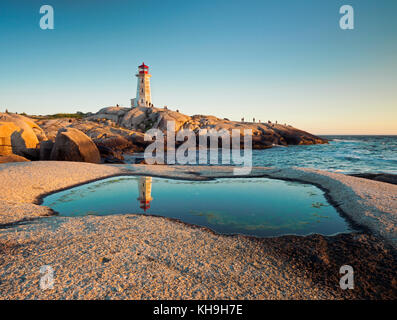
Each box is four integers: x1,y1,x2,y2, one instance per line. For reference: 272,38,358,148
50,128,101,163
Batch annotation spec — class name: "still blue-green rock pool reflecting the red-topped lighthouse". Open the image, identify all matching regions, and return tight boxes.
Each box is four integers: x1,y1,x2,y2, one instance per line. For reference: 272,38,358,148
43,176,353,237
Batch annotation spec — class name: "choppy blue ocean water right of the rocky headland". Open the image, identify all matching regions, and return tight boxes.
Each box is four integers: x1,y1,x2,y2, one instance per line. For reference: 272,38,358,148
125,136,397,174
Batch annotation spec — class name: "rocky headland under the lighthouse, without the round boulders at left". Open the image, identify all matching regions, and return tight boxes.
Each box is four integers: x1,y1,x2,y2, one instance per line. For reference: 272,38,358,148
66,107,327,152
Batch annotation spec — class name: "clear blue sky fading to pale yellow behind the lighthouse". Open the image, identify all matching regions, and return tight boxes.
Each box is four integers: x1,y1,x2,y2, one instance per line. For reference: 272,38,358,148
0,0,397,134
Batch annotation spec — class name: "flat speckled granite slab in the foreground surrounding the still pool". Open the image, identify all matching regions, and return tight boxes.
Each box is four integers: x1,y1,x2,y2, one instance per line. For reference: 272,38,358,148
0,162,397,299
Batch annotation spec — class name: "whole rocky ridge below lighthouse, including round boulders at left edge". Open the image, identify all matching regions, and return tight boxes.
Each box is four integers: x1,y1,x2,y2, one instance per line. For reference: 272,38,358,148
0,107,327,163
